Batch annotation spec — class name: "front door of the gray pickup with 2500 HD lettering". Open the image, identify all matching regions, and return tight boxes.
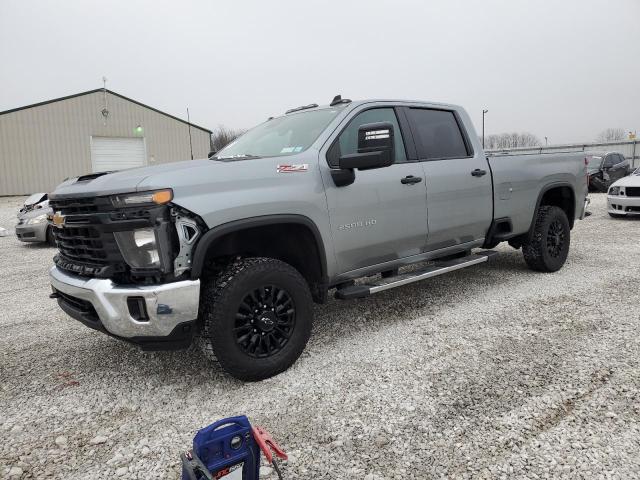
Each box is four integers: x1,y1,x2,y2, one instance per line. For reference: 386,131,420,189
321,106,427,273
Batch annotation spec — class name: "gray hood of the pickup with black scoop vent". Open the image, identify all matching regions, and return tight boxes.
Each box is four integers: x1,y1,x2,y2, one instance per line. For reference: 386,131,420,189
49,160,221,199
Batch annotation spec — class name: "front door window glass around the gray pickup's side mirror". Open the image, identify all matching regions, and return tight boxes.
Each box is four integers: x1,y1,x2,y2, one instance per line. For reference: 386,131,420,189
327,107,407,167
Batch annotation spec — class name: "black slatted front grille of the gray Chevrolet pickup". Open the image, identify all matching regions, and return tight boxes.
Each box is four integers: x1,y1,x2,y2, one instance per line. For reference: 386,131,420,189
49,197,127,278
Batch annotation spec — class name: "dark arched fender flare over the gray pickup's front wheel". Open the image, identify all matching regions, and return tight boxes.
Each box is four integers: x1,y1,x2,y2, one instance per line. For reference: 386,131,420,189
191,214,327,280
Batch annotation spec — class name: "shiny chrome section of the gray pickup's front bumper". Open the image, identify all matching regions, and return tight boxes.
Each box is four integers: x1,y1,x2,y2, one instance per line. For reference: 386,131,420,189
49,267,200,338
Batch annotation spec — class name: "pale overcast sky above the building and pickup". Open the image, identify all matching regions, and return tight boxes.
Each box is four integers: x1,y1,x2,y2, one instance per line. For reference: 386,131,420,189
0,0,640,143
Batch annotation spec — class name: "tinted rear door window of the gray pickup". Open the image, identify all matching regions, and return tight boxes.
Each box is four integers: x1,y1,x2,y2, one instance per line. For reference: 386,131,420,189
407,108,470,160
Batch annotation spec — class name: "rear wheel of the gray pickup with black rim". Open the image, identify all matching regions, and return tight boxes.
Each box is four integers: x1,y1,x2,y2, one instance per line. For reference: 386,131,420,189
522,205,571,272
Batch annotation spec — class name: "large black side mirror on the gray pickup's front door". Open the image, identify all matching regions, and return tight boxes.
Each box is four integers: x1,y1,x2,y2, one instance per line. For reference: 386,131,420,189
338,122,395,170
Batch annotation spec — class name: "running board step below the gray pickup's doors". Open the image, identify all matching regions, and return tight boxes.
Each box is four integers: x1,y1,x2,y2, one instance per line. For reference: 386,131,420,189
335,250,498,300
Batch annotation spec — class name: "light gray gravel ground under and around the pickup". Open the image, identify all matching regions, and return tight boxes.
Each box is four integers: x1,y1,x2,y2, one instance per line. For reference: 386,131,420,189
0,194,640,480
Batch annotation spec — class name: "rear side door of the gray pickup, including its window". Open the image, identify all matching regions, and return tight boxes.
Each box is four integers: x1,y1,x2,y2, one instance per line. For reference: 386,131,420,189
403,107,493,250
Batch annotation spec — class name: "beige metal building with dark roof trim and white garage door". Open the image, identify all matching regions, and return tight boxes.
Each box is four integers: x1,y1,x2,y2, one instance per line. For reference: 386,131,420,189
0,88,211,196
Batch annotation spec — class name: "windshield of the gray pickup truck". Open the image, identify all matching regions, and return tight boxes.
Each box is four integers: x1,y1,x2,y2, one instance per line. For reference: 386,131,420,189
212,108,340,160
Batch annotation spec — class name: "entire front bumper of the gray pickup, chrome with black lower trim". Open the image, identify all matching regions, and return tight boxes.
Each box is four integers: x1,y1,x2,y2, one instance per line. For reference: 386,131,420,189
49,267,200,350
